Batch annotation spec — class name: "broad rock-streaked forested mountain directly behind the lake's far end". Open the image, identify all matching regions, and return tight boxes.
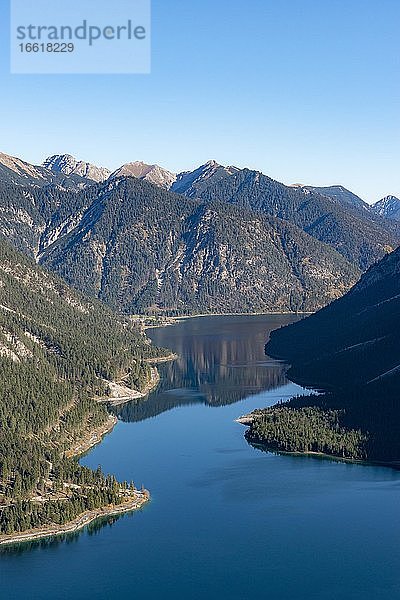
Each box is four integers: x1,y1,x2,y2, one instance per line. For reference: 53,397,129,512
40,178,359,312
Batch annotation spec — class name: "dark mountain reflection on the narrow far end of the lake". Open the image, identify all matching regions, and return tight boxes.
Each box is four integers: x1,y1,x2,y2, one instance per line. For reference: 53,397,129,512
112,315,295,422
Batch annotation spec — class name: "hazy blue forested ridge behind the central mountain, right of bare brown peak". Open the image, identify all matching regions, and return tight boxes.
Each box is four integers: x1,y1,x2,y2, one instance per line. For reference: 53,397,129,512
180,169,400,270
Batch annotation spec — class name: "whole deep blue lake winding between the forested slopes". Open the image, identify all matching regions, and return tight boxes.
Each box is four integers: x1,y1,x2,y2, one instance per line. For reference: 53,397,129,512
0,316,400,600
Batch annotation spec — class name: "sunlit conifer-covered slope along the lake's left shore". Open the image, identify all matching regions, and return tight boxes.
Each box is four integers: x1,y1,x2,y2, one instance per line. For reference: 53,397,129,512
0,240,164,533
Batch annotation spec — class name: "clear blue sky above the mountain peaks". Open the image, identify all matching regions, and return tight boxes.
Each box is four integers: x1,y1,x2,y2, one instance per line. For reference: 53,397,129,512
0,0,400,202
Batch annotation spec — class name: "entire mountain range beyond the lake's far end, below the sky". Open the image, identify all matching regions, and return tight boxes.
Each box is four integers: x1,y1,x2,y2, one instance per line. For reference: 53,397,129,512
0,154,400,313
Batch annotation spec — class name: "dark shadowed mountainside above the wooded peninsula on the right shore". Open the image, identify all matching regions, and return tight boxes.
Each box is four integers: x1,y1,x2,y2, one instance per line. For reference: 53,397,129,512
267,244,400,389
